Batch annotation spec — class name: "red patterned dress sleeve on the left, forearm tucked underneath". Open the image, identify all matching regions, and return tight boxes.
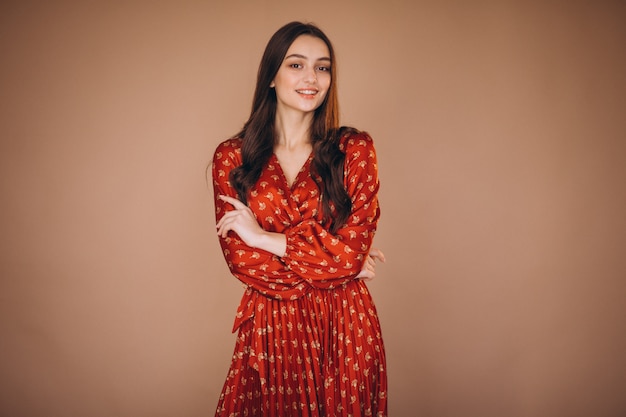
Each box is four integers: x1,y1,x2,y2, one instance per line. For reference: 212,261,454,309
211,139,305,299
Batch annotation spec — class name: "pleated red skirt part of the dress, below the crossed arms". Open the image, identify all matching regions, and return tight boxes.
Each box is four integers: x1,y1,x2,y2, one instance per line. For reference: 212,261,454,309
215,280,387,417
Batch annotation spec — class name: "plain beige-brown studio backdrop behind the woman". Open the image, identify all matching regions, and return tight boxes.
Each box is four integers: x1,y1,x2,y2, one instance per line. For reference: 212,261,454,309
0,0,626,417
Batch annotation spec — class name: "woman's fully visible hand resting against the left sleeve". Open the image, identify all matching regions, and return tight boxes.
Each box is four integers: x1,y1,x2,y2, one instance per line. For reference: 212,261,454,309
216,195,265,247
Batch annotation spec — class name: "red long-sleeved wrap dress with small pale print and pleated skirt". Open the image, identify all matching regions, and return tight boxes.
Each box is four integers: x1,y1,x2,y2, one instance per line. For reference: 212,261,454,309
212,133,387,417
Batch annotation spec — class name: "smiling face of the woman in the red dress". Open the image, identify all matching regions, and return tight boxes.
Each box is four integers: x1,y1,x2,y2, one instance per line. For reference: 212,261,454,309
270,35,331,117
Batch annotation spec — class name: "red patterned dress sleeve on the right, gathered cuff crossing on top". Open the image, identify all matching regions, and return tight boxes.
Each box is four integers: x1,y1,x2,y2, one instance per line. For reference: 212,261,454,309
282,133,380,288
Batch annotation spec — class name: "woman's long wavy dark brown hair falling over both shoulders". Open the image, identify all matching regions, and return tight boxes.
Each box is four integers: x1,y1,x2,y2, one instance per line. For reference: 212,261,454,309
229,22,354,232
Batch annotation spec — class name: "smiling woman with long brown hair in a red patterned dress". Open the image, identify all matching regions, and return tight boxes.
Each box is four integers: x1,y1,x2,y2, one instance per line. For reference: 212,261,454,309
212,22,387,417
